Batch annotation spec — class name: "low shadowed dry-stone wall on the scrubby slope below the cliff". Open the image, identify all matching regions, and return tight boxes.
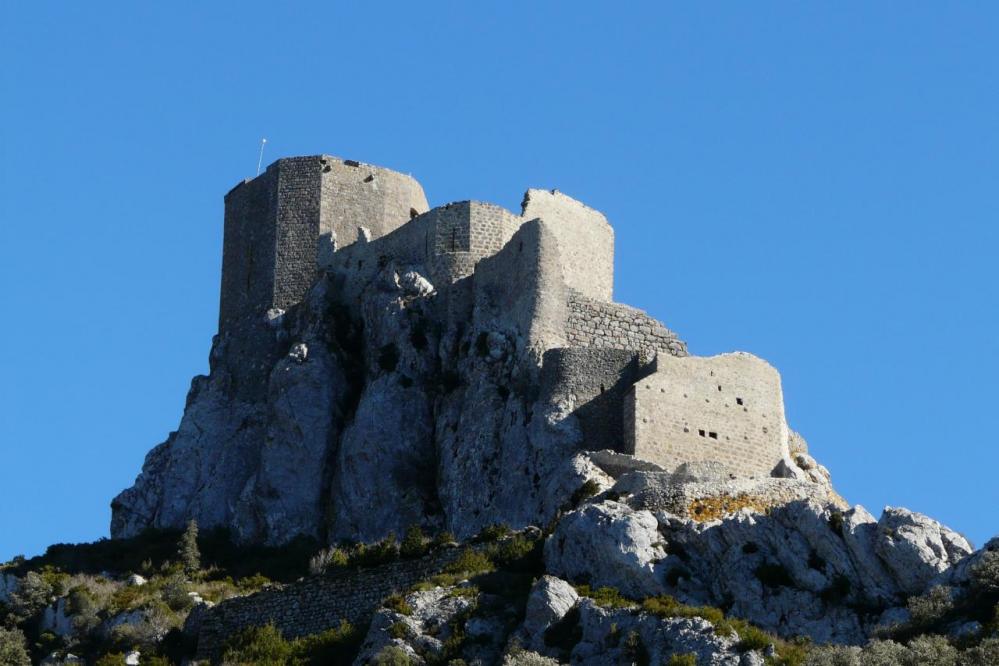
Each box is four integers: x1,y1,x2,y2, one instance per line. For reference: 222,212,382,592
196,548,461,659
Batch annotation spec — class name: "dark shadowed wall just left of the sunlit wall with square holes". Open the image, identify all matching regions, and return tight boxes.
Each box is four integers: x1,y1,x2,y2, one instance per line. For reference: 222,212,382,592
541,347,651,451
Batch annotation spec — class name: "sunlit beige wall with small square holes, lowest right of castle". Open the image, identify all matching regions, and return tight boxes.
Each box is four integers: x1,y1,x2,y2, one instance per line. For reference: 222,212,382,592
625,352,788,477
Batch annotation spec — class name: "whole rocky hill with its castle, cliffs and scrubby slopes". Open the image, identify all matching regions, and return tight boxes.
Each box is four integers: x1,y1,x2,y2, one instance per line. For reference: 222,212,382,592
0,155,999,666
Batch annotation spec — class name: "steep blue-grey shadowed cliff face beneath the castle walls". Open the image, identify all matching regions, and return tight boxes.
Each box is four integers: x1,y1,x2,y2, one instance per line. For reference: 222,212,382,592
112,265,603,544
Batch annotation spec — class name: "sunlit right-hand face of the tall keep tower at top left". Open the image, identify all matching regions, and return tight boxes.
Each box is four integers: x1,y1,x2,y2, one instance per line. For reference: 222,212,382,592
317,155,429,249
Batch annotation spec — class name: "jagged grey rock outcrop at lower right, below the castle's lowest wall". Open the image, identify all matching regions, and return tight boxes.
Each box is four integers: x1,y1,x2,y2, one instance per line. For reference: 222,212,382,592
545,501,971,643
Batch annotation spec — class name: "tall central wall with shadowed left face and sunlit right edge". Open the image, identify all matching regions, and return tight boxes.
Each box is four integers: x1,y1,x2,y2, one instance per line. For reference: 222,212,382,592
473,220,567,362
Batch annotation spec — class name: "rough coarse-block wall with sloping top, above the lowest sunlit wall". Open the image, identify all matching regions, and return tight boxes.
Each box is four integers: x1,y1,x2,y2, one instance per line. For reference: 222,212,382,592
566,290,687,358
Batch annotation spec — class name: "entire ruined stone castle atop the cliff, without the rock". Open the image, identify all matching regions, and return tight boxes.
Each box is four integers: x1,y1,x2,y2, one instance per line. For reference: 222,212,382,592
219,155,788,477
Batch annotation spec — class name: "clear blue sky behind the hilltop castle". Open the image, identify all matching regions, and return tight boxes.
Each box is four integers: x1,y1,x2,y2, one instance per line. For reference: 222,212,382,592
0,0,999,560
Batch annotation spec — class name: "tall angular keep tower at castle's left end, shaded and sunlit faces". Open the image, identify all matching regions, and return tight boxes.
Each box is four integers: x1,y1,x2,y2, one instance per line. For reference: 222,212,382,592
219,155,428,332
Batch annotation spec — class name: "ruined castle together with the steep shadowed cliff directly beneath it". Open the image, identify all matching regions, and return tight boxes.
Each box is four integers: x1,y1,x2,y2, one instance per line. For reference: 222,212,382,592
112,155,808,543
